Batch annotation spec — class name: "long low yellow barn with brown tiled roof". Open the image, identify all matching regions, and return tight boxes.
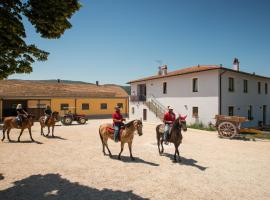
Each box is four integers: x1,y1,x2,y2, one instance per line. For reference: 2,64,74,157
0,80,128,120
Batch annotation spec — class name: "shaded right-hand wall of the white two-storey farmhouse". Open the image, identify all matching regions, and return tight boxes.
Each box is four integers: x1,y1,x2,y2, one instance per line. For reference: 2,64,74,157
222,71,270,126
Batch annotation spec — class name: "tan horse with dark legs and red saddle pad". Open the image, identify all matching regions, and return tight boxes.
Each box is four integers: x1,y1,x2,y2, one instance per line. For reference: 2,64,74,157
99,120,143,160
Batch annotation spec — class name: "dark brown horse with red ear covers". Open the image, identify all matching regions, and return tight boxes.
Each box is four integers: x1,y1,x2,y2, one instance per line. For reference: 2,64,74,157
156,115,187,162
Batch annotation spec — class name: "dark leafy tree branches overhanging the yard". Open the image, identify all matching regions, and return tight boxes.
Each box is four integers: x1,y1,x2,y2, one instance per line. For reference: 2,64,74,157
0,0,81,80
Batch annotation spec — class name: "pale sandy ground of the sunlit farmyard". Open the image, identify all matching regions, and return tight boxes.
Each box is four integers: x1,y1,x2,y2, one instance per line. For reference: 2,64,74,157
0,120,270,200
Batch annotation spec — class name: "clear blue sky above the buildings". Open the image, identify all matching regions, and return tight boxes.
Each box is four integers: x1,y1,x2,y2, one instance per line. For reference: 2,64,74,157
9,0,270,85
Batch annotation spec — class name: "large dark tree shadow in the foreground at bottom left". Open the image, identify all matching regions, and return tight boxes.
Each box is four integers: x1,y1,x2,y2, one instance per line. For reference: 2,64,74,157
0,174,146,200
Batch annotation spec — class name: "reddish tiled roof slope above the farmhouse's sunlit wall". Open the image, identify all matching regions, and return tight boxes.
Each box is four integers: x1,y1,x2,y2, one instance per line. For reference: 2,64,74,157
128,65,223,83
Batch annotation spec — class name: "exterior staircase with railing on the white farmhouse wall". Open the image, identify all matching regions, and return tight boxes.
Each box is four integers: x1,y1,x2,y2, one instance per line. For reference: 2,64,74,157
145,95,167,121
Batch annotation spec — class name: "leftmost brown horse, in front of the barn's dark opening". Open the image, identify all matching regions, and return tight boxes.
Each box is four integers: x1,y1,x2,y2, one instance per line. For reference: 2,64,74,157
2,115,35,142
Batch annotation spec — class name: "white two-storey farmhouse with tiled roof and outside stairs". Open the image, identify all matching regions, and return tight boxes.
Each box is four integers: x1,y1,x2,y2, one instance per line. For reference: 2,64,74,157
129,59,270,126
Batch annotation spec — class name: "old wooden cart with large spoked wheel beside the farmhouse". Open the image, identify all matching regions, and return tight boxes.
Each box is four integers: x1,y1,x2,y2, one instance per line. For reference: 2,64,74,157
215,115,248,138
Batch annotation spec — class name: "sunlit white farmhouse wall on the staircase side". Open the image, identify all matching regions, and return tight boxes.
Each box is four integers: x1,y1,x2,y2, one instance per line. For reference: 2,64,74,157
130,70,219,124
